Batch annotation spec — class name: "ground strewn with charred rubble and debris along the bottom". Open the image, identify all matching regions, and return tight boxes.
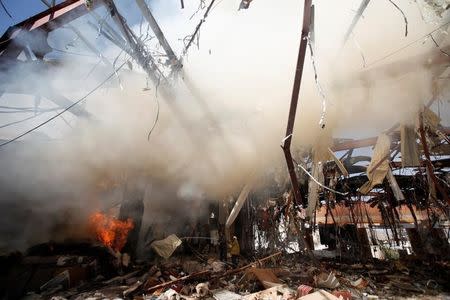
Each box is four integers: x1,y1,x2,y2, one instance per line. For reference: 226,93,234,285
1,243,450,300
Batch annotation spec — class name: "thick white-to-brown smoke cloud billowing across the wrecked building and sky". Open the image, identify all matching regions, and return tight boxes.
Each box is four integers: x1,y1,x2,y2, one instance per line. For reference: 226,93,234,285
0,0,449,251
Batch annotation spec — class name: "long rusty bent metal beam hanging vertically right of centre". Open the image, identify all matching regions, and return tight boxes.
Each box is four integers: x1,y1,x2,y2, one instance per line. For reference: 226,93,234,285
281,0,312,209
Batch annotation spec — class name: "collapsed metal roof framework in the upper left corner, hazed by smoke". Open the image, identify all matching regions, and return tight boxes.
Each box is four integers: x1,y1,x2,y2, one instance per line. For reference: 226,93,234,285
0,0,181,117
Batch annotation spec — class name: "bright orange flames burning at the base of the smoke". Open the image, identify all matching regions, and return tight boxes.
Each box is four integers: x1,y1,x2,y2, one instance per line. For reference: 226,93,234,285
89,212,134,251
